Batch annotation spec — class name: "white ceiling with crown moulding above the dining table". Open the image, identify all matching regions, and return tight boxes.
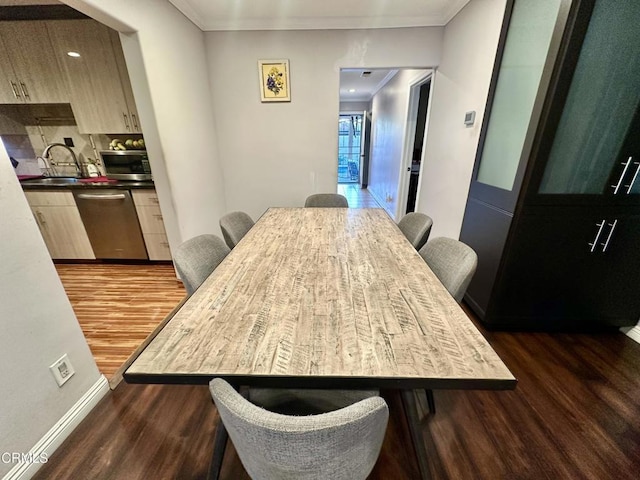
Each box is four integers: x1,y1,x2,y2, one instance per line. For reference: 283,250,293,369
169,0,470,31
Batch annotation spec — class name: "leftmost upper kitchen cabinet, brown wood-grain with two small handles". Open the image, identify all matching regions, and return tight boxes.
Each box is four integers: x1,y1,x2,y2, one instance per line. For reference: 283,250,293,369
0,21,69,103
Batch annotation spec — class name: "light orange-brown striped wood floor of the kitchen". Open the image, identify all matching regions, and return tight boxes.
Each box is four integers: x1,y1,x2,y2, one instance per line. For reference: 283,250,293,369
56,264,186,380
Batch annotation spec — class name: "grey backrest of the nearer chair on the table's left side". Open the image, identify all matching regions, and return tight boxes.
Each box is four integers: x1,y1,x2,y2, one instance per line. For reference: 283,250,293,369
173,233,231,295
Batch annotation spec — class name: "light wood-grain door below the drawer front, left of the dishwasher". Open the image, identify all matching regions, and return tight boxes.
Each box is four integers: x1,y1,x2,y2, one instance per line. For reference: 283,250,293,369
32,206,96,259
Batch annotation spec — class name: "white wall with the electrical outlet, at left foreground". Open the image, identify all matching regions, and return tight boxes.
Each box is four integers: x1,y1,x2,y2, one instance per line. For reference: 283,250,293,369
0,143,101,477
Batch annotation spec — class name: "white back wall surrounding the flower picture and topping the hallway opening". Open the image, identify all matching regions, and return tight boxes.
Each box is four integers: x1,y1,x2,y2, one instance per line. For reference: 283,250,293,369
205,27,443,218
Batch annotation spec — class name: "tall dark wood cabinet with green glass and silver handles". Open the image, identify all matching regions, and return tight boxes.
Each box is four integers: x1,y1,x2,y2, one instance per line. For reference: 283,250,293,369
460,0,640,330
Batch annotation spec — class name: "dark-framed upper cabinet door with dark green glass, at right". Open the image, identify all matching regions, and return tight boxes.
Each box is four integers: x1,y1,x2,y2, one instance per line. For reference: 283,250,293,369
527,0,640,205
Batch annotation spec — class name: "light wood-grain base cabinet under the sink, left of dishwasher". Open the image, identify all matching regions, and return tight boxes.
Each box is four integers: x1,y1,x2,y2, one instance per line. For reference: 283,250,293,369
25,191,96,260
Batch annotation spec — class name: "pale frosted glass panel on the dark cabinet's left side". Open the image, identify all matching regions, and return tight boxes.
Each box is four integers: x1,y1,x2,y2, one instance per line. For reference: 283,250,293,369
477,0,562,190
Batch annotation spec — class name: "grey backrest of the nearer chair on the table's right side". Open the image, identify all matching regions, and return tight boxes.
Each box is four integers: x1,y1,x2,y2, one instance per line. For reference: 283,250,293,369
418,237,478,303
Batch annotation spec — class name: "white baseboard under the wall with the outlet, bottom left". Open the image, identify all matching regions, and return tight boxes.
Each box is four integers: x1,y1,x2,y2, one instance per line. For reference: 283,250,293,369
2,375,110,480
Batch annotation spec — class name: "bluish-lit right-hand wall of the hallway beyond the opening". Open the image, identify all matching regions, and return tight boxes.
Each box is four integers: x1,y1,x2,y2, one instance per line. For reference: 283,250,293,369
368,69,427,220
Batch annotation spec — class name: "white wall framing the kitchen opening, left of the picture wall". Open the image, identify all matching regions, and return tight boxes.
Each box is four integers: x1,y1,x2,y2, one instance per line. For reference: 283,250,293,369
65,0,227,242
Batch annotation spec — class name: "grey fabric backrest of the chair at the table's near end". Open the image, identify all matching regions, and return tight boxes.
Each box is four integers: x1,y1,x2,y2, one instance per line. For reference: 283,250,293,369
209,378,389,480
